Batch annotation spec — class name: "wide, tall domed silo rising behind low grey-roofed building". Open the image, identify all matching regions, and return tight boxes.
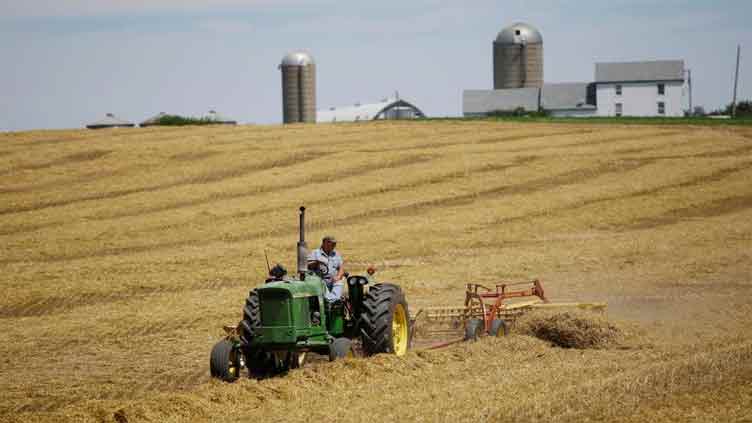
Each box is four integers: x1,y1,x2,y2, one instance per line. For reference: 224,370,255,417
493,22,543,90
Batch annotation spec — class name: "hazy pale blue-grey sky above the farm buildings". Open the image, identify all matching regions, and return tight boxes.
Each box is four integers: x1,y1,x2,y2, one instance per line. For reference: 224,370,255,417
0,0,752,131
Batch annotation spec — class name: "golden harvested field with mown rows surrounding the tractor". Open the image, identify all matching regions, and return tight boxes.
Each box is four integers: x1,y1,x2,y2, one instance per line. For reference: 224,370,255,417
0,121,752,422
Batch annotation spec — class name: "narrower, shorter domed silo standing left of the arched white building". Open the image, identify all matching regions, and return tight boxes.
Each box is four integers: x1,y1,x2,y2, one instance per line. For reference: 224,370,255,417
279,51,316,123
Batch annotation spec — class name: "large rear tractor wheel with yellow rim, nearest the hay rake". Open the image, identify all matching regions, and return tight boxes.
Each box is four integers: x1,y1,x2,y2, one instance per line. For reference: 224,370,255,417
360,283,411,356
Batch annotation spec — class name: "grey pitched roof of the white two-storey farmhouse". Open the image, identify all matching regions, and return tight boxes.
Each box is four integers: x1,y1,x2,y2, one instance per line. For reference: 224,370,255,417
595,60,684,83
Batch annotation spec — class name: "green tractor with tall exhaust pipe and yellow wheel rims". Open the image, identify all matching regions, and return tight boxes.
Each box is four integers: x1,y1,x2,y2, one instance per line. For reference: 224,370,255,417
209,207,411,382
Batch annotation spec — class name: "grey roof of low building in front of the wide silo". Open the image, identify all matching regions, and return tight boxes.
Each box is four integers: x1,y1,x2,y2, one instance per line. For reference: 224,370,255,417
462,87,540,114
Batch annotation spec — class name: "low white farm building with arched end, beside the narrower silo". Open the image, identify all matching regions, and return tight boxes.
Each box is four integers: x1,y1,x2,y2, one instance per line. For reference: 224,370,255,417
316,97,426,122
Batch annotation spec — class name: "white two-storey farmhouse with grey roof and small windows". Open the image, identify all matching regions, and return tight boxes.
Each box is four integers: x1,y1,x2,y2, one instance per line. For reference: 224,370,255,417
595,60,685,117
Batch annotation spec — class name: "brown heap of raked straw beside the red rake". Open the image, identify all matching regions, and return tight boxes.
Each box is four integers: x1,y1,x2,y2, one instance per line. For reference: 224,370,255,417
515,311,622,349
